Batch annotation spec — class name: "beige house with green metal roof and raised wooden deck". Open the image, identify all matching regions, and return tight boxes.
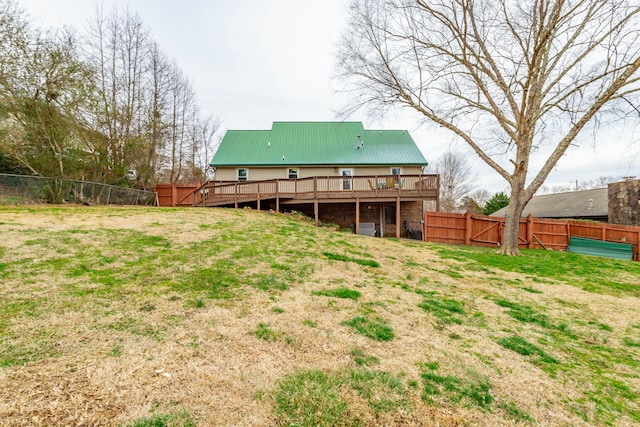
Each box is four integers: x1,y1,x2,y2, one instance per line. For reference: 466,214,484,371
200,122,438,237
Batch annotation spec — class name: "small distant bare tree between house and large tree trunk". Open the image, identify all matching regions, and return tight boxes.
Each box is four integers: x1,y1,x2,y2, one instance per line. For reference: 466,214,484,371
436,151,476,212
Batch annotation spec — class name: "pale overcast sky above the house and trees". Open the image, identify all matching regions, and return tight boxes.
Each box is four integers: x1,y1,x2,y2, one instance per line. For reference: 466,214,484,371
21,0,640,193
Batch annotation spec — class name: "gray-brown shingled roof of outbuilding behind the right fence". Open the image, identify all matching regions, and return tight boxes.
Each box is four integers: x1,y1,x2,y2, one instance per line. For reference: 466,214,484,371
491,188,609,218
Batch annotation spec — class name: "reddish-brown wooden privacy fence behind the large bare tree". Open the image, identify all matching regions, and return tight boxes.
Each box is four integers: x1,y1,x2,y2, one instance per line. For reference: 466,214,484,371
422,212,640,261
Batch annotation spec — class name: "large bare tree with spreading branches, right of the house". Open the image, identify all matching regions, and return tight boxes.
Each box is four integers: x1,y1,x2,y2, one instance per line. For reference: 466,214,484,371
338,0,640,254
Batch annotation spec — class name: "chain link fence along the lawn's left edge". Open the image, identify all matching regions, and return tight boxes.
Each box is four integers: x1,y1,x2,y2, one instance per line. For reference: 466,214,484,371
0,174,157,206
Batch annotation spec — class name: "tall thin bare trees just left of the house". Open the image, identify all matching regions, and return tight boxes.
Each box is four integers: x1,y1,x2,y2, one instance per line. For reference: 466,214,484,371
87,9,218,188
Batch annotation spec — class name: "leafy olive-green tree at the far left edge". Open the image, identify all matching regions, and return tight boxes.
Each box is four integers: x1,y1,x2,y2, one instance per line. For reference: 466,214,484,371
0,17,92,186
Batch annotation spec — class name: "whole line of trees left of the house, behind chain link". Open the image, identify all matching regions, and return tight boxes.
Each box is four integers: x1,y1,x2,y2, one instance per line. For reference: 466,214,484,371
0,0,221,189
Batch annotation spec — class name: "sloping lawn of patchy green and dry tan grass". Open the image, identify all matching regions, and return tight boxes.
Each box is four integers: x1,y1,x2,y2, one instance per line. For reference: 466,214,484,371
0,206,640,427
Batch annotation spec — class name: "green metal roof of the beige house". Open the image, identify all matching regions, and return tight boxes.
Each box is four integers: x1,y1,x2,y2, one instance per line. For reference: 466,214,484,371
211,122,427,167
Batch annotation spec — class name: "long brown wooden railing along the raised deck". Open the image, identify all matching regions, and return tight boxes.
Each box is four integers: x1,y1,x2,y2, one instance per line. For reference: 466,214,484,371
192,175,439,206
